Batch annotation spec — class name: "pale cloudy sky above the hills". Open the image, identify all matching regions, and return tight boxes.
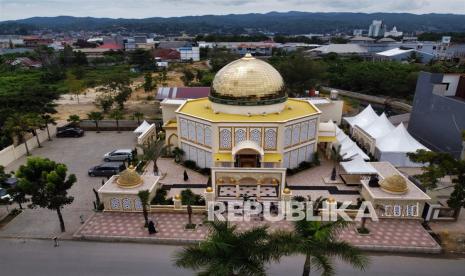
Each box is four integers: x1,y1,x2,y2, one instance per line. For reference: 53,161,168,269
0,0,465,21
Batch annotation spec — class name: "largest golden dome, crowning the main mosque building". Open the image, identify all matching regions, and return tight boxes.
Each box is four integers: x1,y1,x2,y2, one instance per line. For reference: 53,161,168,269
210,54,287,105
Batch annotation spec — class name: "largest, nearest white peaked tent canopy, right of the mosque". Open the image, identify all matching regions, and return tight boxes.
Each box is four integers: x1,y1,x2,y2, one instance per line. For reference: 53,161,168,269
376,123,428,152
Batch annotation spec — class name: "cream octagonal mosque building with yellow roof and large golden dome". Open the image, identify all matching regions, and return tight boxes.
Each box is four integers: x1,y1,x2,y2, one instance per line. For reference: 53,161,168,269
163,54,328,200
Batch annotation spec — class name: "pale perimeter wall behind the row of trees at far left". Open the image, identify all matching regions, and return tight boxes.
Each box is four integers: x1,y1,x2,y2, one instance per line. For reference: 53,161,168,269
0,125,57,167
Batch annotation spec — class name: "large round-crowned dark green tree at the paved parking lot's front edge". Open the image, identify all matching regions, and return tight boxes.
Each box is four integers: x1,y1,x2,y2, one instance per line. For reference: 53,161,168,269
16,157,76,232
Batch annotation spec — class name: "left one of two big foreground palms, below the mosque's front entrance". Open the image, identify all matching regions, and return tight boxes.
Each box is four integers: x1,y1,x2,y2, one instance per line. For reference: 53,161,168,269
174,221,282,276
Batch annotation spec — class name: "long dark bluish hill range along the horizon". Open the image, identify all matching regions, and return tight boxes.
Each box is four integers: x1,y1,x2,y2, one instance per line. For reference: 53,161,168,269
0,11,465,34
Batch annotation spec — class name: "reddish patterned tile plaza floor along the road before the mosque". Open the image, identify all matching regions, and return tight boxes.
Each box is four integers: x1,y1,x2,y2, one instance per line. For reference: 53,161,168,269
74,212,440,252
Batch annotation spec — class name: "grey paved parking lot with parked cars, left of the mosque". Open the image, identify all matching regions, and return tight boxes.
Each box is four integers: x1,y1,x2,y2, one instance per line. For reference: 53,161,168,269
0,131,136,238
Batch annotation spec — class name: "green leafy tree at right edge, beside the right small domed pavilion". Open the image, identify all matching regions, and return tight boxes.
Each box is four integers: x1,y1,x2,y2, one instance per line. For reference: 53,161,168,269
407,150,465,218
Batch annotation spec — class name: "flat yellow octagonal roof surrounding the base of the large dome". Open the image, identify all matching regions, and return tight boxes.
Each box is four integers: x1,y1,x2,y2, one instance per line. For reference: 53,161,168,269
176,98,321,123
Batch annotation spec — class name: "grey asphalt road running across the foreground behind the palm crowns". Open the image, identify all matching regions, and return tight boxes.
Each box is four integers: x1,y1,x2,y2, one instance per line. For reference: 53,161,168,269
0,239,465,276
